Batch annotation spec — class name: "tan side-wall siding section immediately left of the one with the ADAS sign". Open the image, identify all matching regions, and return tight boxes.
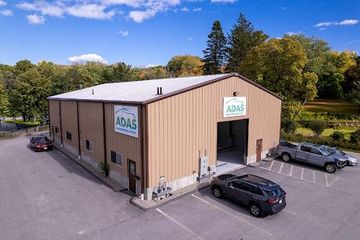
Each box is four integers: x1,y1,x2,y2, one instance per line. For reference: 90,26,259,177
79,102,104,162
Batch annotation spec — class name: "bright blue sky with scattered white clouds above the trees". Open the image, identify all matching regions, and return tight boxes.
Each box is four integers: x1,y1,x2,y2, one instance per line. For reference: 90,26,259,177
0,0,360,67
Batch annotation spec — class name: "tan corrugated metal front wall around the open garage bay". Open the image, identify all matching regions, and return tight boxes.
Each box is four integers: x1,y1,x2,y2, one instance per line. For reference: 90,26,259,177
147,77,281,187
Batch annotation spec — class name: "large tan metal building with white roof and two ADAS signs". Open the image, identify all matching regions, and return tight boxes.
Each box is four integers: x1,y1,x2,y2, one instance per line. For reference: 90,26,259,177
48,74,281,200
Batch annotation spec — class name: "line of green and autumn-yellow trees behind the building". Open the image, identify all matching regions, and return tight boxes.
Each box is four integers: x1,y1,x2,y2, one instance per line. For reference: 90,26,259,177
0,14,360,121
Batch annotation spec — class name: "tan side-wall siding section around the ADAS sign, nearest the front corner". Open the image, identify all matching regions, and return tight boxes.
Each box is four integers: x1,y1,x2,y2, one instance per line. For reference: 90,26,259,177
105,103,142,179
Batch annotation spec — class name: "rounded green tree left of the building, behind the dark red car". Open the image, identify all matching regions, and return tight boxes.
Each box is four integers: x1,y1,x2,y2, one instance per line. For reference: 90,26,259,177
9,68,50,121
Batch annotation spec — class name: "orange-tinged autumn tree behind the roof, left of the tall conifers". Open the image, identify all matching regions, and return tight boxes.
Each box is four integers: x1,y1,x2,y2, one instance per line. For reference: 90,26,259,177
167,55,204,77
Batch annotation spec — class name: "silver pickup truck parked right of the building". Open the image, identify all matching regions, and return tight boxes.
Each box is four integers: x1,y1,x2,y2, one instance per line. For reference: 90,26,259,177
277,142,347,173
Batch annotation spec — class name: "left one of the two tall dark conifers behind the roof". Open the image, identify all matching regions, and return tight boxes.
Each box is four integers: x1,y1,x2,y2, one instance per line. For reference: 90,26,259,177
203,21,226,74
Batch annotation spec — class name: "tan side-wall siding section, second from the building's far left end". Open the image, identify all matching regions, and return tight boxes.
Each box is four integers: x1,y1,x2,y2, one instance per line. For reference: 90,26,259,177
60,101,78,149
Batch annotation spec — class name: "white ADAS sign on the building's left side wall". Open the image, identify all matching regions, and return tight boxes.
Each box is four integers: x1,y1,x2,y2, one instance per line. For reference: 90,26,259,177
114,105,139,137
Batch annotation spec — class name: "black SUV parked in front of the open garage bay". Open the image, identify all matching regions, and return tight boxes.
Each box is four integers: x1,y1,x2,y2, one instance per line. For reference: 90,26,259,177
210,174,286,217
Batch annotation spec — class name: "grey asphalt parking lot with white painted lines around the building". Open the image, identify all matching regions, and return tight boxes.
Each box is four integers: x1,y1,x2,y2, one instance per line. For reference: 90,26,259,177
0,137,360,240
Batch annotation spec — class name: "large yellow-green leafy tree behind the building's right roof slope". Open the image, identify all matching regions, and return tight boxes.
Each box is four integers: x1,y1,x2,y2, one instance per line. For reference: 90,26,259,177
240,37,317,103
